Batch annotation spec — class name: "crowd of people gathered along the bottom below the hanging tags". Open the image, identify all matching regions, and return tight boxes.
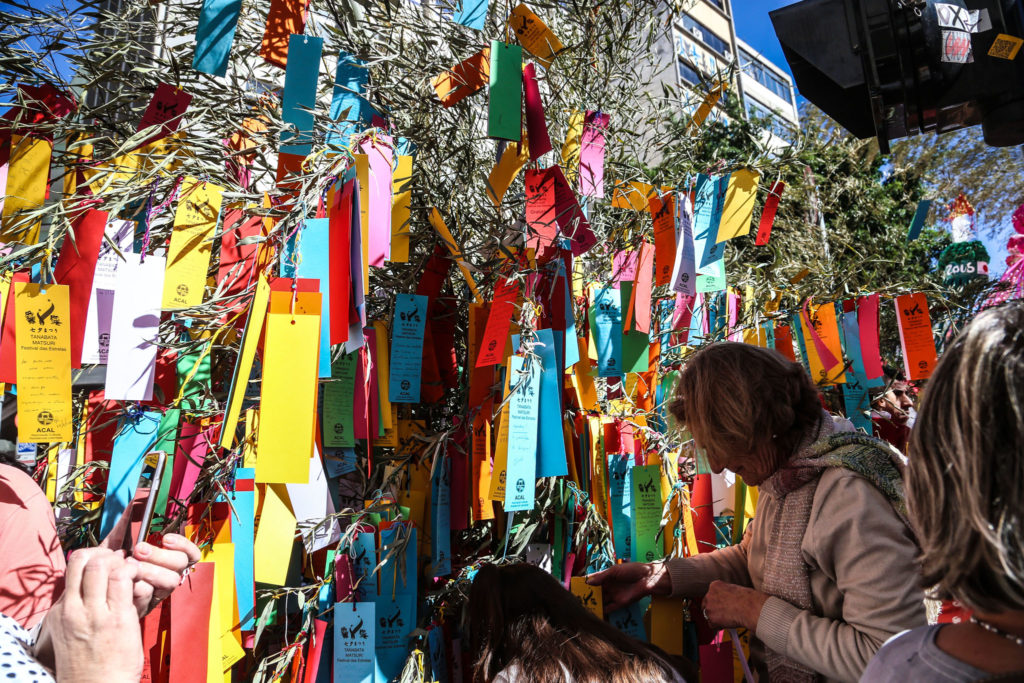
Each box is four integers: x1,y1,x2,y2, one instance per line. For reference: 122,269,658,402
0,303,1024,683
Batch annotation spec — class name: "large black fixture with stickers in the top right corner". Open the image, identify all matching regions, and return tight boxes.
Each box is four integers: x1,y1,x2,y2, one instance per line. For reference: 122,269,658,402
769,0,1024,152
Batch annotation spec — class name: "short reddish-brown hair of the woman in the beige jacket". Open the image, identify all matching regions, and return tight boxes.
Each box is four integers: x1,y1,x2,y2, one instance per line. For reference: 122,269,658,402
669,342,822,462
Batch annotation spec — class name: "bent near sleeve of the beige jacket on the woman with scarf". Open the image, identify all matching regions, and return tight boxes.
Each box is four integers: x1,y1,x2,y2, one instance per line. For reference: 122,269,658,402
757,473,926,681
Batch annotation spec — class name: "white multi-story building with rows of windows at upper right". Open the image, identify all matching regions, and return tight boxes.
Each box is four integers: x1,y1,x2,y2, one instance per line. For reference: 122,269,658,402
673,0,800,144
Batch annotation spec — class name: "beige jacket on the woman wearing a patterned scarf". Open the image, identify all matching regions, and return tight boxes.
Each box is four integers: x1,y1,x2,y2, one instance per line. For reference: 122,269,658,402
668,468,926,681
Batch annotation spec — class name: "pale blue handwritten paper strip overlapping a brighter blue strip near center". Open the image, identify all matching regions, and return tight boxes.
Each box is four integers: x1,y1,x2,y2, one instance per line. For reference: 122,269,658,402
505,355,541,512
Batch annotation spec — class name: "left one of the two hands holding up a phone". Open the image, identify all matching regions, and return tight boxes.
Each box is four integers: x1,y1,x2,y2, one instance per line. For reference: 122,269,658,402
45,548,143,683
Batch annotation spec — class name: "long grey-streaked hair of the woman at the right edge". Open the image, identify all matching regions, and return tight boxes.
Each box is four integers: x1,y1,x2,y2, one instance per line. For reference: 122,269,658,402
907,302,1024,612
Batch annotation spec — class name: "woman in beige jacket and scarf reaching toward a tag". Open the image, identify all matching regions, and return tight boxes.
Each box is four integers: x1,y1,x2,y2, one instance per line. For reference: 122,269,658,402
589,343,926,682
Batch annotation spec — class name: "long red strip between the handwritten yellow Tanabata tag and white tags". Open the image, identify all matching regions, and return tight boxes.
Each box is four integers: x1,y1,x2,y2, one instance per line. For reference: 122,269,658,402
53,209,106,368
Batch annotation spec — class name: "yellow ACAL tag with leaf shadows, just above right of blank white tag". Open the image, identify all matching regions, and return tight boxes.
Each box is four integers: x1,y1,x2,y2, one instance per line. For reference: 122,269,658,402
163,177,224,308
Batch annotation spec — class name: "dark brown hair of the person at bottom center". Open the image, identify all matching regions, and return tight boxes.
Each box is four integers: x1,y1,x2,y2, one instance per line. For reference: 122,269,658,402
468,564,686,683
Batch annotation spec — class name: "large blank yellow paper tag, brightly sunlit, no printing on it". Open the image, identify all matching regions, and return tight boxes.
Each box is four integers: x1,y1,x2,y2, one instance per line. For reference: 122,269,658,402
256,312,319,483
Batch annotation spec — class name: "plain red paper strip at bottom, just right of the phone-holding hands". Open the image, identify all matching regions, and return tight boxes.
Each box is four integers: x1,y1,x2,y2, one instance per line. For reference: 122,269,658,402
170,562,216,683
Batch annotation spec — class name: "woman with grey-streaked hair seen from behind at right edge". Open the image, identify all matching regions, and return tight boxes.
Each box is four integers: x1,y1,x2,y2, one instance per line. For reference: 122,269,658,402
861,303,1024,683
